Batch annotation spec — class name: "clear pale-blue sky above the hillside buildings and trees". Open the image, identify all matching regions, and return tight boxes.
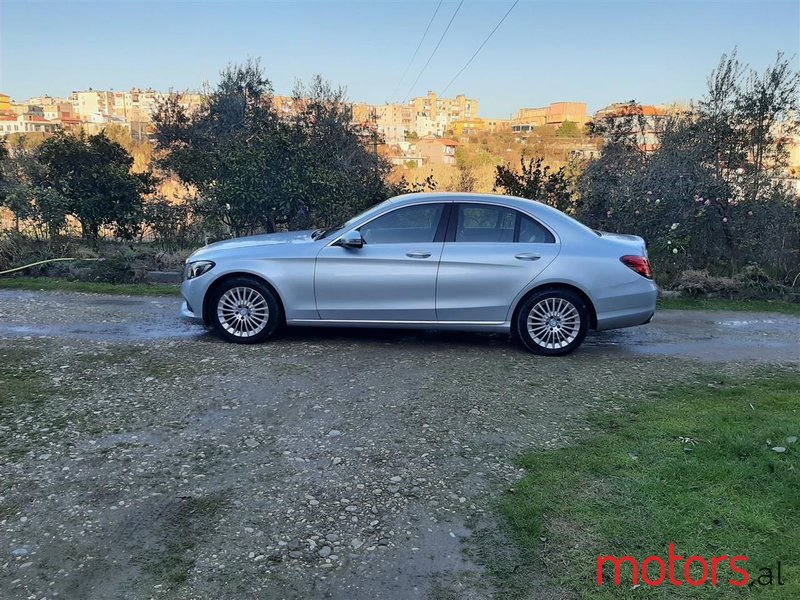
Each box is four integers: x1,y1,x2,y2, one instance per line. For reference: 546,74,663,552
0,0,800,117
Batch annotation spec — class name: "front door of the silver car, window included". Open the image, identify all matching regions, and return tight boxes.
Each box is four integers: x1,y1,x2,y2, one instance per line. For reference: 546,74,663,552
314,203,447,321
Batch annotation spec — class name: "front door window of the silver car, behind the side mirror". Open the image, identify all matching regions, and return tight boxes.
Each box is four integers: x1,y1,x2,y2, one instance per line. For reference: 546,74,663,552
359,204,444,244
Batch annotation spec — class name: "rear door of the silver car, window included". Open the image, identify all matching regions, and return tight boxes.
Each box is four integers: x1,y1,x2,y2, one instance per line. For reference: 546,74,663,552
436,202,560,322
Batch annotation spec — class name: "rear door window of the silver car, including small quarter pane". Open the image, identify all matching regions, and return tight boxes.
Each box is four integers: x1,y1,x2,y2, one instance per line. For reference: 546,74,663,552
448,203,556,244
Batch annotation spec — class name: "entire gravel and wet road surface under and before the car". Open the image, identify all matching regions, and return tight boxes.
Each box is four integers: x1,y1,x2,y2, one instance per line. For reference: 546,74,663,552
0,291,800,600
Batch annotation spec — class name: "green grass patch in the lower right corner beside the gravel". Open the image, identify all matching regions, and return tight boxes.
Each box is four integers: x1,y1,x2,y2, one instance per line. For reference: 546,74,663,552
500,372,800,599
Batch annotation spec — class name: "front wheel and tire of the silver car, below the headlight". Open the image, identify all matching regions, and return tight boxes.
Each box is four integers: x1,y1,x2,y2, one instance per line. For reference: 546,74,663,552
208,277,283,344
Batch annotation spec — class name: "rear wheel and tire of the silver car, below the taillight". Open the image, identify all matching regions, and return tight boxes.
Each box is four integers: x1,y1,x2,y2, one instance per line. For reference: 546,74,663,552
514,289,589,356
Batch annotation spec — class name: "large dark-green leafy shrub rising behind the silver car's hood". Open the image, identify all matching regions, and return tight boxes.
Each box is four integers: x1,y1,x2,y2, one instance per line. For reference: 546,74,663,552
153,61,390,235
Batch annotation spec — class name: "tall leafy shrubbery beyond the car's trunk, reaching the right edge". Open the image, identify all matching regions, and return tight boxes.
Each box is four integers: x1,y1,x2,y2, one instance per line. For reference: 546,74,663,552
578,54,800,281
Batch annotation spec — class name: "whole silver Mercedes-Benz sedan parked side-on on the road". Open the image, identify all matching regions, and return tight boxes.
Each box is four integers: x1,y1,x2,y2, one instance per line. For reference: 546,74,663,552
181,193,657,356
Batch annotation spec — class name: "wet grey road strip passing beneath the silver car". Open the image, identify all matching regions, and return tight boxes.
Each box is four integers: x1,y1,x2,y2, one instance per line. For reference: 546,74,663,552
0,290,800,362
